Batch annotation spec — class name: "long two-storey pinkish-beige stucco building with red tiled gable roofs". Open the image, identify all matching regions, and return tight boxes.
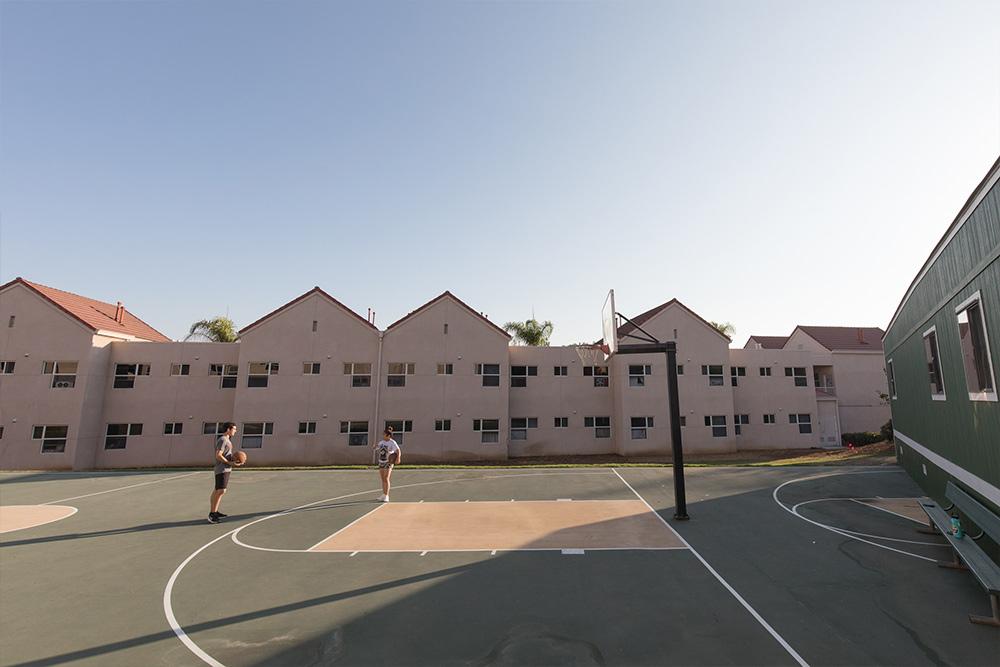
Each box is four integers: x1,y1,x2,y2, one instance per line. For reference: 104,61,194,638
0,278,889,470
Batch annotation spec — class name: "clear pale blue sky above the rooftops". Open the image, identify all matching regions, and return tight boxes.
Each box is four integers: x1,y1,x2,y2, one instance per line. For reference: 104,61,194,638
0,0,1000,343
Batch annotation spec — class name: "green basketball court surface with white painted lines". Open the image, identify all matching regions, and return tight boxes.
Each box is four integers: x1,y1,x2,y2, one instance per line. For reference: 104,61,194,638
0,466,1000,666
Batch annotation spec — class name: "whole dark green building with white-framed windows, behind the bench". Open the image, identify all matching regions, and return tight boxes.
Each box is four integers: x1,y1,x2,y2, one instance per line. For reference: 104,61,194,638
884,159,1000,514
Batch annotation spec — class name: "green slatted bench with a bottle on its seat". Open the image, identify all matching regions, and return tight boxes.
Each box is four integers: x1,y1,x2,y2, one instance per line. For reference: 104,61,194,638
920,482,1000,627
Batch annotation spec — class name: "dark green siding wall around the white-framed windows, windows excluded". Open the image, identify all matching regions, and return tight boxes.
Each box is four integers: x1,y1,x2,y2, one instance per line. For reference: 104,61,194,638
885,172,1000,512
